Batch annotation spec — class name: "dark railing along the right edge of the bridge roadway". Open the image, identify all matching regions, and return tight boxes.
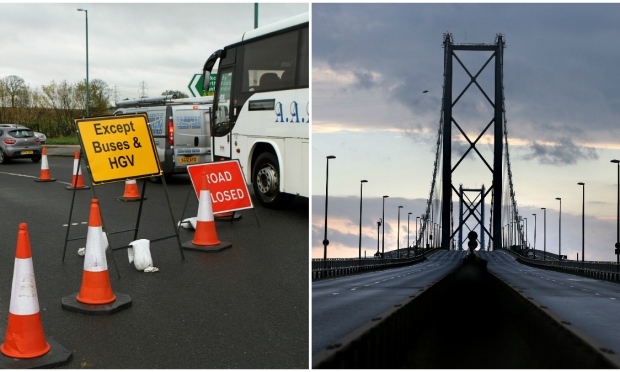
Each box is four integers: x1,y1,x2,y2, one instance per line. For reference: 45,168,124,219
503,249,620,282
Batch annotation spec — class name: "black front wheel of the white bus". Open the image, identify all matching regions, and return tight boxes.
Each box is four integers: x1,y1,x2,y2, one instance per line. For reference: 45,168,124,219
252,152,292,207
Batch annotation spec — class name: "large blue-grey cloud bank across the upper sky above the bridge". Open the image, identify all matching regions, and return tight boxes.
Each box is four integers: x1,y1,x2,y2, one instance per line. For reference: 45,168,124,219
313,4,620,150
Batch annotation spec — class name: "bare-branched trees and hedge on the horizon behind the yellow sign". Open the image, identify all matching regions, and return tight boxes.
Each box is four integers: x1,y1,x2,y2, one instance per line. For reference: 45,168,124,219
0,75,187,138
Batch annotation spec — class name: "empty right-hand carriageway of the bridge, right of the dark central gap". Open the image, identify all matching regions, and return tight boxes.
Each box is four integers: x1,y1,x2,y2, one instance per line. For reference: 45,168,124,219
478,251,620,353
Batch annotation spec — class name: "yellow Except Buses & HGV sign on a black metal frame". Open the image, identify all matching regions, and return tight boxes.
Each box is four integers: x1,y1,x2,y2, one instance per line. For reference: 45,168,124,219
75,114,162,184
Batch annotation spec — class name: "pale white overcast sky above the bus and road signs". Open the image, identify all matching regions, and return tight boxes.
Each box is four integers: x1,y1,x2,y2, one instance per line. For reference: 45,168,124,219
0,2,309,100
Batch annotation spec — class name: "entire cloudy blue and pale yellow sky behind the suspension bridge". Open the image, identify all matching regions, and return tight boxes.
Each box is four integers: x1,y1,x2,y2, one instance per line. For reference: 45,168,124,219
312,3,620,261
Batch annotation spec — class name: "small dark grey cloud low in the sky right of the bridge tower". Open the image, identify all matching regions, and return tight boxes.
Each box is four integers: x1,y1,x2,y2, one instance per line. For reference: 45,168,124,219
522,137,598,166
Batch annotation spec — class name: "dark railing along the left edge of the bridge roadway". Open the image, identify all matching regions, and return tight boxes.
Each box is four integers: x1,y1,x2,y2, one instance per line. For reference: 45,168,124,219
312,249,438,280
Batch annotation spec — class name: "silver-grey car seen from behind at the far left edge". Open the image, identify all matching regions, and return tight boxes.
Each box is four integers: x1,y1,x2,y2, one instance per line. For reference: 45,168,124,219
0,124,41,164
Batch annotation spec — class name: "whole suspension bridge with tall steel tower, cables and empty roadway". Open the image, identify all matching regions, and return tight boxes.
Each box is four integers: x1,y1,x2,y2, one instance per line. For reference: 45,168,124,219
312,33,620,368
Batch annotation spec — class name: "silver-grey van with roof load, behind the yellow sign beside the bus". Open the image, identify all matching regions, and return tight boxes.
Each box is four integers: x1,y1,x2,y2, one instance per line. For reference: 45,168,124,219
114,96,213,177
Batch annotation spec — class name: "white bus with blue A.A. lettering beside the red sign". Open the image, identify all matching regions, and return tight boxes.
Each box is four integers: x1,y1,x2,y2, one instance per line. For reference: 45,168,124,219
203,13,310,207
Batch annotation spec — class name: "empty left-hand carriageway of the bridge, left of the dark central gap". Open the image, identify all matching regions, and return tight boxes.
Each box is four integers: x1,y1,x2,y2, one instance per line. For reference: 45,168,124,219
312,251,464,355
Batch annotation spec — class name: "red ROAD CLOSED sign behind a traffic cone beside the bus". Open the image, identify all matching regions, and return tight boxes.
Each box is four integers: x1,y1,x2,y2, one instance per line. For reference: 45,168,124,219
187,160,254,213
